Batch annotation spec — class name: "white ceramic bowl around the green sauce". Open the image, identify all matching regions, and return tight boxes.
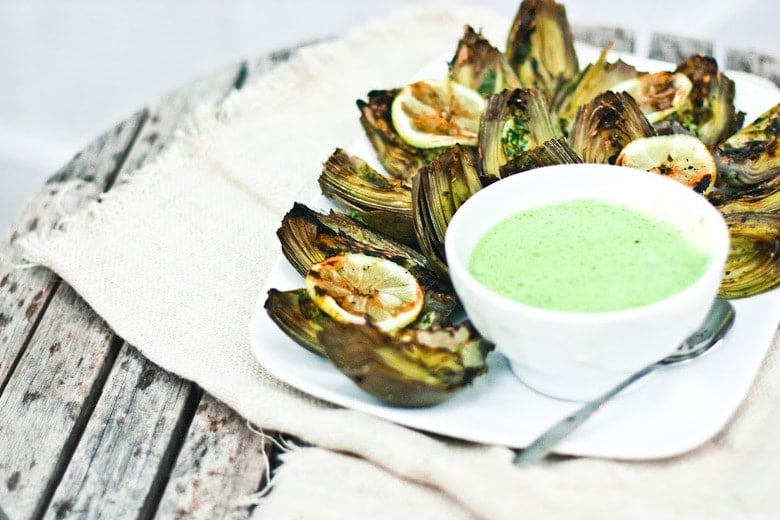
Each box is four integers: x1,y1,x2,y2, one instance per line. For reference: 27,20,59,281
445,164,729,400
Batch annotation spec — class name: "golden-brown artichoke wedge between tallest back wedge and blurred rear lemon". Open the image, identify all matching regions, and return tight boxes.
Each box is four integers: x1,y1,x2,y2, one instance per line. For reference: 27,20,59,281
551,44,638,130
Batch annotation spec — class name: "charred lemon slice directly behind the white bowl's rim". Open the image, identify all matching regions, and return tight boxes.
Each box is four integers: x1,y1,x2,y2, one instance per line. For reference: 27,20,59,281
615,134,717,194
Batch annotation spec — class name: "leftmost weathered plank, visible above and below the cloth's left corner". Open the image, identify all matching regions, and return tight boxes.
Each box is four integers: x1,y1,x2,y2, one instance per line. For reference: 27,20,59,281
0,111,147,393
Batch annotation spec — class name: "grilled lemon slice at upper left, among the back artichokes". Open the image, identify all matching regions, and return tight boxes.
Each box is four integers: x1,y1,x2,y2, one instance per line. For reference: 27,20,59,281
390,79,485,148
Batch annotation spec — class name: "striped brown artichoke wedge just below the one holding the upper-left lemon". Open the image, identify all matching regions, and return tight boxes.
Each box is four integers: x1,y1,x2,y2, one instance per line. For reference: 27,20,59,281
319,148,416,245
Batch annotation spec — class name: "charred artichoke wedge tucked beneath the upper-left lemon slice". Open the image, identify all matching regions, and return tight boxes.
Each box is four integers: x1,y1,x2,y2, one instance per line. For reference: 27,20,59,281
357,89,446,179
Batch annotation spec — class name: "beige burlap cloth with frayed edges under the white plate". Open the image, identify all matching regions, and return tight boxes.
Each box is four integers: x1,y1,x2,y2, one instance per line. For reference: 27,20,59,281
16,4,780,519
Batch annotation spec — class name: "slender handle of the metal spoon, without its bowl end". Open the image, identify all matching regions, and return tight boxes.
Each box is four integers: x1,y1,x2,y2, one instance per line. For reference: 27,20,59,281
515,363,661,466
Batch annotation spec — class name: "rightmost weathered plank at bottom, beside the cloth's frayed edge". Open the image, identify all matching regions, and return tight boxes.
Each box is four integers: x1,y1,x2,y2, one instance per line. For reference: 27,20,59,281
157,395,273,520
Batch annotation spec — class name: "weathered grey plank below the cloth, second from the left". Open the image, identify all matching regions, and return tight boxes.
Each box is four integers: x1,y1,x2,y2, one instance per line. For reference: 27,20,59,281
0,284,116,518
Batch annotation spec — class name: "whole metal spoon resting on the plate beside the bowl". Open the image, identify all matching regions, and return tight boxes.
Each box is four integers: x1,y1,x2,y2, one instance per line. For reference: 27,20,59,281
515,300,735,466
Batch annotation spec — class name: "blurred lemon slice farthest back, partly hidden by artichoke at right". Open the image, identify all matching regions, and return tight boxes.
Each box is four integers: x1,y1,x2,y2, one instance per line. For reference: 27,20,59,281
610,71,693,123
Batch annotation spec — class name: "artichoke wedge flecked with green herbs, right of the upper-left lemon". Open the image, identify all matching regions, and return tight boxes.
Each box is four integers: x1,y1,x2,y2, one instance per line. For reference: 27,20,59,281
478,88,563,180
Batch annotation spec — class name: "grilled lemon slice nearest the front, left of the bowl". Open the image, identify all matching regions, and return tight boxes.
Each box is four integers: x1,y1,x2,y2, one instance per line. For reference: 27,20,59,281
306,253,425,332
